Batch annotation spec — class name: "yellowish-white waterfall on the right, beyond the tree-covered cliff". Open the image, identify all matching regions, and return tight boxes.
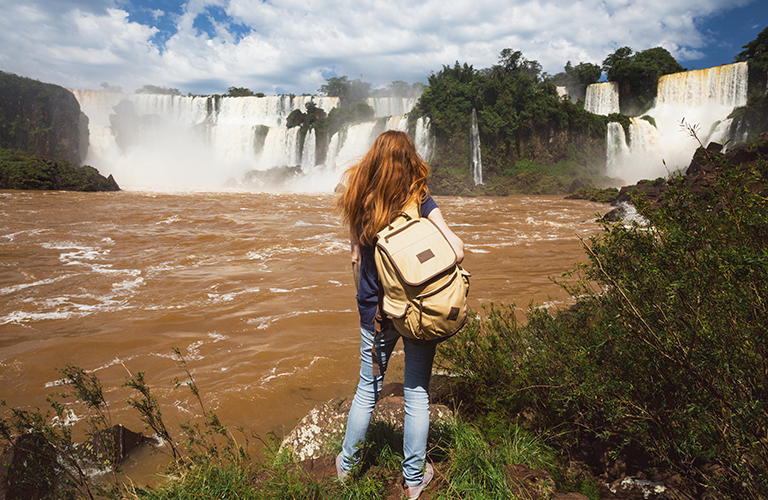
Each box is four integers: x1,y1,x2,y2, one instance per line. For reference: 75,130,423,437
600,62,748,184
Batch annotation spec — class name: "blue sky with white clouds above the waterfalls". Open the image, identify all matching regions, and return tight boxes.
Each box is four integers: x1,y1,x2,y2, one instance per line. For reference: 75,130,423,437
0,0,768,94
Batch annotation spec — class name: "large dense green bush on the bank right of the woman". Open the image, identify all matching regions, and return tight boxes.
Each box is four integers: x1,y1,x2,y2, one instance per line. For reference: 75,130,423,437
441,147,768,498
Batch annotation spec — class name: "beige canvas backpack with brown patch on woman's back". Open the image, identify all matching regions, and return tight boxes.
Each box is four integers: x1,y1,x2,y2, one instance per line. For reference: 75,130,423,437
374,203,470,340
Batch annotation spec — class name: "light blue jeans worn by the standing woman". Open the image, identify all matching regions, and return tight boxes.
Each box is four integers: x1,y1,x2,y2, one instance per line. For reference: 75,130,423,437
341,328,435,486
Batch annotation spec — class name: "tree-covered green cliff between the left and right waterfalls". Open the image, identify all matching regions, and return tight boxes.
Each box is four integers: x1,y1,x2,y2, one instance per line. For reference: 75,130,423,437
414,56,606,195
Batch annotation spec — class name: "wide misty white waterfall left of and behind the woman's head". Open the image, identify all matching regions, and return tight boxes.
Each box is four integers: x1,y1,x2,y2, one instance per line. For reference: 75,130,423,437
73,90,431,191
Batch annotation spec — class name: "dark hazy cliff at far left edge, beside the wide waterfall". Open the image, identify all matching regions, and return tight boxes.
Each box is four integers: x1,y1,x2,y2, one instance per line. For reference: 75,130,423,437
0,72,88,165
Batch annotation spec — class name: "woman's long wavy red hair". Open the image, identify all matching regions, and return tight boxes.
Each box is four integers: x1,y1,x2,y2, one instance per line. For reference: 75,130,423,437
337,130,429,245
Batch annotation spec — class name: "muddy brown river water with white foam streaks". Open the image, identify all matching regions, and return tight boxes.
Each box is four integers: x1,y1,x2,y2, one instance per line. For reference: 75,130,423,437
0,191,609,481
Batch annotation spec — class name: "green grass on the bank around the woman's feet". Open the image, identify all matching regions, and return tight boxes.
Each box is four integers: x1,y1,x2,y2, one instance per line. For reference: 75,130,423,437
126,421,588,500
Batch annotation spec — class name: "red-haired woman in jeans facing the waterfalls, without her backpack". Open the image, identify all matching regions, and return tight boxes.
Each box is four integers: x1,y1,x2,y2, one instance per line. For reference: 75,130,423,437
336,130,464,499
